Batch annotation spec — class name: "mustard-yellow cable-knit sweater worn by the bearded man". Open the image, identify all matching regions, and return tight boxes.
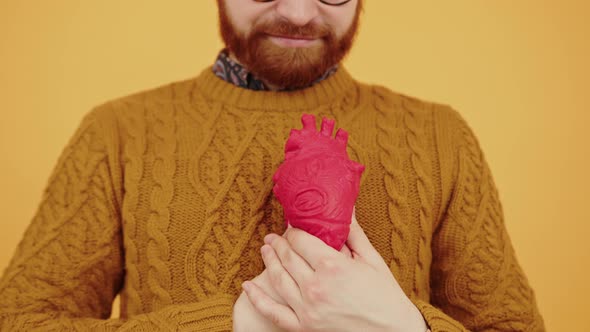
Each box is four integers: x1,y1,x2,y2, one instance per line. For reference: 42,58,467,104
0,68,544,332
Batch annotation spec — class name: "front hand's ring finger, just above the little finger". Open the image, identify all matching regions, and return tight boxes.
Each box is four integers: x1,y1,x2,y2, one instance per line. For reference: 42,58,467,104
260,244,302,309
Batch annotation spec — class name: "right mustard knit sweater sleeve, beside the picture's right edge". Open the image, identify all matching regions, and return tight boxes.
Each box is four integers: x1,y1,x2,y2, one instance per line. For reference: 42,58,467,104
415,107,545,332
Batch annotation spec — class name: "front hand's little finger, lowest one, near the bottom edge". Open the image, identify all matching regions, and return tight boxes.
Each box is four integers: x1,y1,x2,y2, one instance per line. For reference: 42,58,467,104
242,281,300,331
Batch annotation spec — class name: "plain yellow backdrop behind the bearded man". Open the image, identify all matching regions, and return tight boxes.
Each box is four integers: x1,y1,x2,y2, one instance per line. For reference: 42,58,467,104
0,0,590,331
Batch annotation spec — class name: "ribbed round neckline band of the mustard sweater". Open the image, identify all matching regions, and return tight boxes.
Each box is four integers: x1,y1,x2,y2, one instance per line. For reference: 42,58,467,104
194,66,357,111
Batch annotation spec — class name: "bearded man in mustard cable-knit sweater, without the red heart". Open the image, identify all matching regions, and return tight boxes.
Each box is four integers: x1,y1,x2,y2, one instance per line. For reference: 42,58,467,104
0,0,544,332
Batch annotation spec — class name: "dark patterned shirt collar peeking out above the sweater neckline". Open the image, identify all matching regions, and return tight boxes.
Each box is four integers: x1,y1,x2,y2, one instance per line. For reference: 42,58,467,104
213,49,338,91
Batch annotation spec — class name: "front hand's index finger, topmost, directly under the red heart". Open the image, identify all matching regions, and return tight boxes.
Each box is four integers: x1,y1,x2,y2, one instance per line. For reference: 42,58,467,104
286,228,342,270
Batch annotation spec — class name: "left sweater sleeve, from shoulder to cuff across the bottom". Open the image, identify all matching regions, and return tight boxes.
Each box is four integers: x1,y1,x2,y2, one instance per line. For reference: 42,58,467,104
0,110,235,331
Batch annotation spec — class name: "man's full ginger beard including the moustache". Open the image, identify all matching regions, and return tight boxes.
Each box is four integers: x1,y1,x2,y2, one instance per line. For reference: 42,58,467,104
217,0,362,89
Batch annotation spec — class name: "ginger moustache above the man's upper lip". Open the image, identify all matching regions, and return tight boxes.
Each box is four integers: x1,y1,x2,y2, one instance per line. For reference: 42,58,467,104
252,20,333,39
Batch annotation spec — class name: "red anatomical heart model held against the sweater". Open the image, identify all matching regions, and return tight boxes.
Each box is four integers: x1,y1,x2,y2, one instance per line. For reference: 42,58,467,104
273,114,365,250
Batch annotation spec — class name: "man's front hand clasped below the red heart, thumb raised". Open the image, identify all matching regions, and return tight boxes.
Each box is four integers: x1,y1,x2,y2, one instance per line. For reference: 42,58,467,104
244,216,427,332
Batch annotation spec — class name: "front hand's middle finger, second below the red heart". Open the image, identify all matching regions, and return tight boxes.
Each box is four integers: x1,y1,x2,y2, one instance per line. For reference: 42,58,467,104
264,233,313,286
